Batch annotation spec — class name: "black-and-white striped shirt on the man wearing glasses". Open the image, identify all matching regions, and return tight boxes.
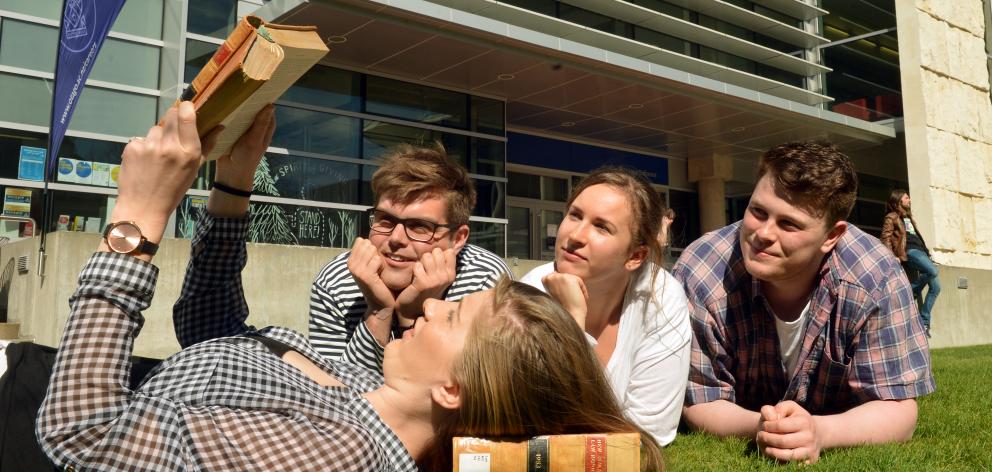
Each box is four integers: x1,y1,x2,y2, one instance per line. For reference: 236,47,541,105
309,244,510,372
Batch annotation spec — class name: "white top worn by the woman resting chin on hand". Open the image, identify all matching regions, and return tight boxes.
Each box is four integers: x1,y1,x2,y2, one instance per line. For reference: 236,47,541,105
520,263,692,445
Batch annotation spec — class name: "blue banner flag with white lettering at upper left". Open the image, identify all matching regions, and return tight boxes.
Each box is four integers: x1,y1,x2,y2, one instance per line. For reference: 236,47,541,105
45,0,124,177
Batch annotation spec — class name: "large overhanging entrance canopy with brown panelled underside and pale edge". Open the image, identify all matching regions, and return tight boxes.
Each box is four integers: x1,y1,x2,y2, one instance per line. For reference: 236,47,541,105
260,0,895,173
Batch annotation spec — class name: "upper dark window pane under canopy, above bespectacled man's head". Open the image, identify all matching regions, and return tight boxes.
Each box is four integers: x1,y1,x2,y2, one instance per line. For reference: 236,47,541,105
365,75,468,129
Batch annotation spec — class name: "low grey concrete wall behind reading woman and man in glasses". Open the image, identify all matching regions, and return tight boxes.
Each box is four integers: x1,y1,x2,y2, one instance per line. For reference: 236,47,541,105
0,232,544,357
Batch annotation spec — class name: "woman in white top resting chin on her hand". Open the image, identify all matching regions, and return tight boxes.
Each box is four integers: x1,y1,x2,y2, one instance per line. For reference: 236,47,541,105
521,167,692,445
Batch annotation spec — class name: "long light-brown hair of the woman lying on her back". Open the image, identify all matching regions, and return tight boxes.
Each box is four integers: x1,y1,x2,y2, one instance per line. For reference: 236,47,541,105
421,277,663,471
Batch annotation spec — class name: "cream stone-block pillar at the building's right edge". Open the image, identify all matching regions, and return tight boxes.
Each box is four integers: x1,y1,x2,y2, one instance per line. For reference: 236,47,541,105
896,0,992,270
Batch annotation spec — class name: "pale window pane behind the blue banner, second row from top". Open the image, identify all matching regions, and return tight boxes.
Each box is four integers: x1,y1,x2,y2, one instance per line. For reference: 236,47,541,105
0,19,159,89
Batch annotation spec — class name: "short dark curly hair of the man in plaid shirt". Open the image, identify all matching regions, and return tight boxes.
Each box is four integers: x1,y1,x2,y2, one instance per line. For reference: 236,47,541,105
758,141,858,226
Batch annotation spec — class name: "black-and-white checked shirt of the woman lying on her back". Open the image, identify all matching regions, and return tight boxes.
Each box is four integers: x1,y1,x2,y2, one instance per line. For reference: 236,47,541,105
37,219,416,471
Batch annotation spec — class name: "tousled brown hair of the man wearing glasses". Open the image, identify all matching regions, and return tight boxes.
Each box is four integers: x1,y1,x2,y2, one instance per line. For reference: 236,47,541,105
372,143,476,225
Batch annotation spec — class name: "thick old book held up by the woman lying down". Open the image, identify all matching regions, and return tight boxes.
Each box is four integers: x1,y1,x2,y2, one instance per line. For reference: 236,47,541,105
180,15,328,160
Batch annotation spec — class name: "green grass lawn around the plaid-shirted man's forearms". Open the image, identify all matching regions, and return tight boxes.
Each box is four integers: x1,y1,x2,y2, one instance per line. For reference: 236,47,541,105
665,345,992,471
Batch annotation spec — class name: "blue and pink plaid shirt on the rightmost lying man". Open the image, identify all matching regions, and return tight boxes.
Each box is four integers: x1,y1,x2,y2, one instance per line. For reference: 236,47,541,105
672,222,935,414
